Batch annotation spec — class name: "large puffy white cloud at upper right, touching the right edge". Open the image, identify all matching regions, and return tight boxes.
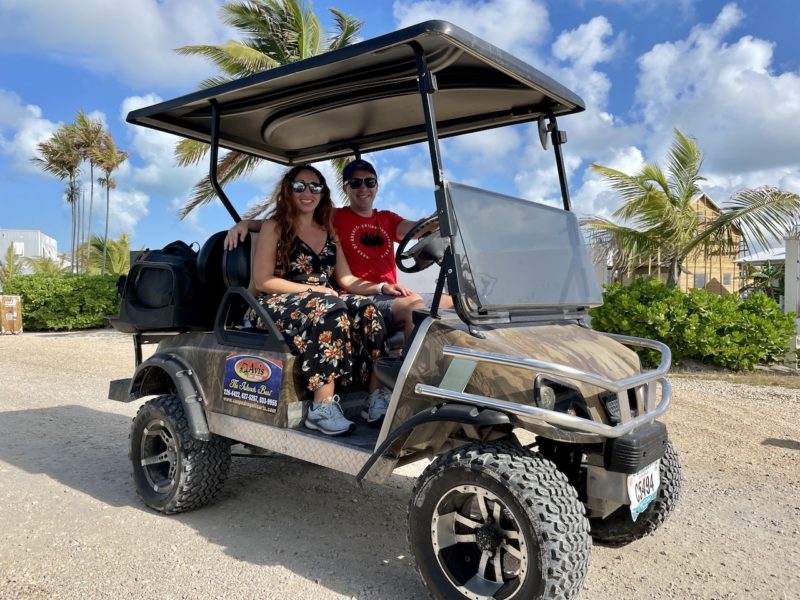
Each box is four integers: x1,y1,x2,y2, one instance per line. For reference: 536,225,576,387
637,4,800,178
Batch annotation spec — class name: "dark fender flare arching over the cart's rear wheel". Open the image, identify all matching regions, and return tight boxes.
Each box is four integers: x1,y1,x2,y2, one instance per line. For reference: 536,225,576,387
129,352,211,441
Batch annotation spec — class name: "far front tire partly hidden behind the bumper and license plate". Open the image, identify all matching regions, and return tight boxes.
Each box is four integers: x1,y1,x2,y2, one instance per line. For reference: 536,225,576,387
589,442,683,547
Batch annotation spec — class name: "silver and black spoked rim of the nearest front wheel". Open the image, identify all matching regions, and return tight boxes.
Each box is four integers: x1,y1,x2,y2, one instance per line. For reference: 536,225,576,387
431,485,528,600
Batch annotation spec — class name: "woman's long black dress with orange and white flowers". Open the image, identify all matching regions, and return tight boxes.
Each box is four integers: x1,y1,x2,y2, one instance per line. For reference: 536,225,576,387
253,237,387,392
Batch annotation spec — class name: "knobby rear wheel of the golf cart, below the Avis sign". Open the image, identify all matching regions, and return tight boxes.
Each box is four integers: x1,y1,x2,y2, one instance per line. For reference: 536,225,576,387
128,395,231,514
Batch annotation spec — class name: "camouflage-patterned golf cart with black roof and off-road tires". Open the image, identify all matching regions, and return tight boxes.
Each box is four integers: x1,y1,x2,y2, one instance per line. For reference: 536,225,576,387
109,21,681,600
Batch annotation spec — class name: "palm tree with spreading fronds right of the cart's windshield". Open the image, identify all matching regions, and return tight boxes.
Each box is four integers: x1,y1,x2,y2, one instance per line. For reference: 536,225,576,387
582,129,800,287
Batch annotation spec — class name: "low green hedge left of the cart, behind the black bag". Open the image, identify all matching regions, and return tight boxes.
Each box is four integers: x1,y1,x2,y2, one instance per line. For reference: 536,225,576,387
3,273,119,331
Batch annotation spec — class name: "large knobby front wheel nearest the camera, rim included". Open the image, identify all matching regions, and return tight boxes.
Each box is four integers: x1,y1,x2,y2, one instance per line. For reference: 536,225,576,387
408,442,591,600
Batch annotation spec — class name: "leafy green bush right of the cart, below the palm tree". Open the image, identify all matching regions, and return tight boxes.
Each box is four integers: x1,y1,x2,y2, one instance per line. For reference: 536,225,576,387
590,278,795,370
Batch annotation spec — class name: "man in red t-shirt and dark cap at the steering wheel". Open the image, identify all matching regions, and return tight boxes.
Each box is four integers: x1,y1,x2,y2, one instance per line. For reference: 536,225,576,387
225,159,452,339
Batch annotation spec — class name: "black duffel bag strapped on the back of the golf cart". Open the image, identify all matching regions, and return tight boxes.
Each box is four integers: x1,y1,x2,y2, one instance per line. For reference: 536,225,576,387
119,241,216,331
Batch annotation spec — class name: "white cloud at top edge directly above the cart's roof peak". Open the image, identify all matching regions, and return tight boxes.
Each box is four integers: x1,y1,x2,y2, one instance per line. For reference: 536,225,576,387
393,0,550,59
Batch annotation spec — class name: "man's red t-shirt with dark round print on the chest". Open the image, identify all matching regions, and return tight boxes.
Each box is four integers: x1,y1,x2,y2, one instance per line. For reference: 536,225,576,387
333,206,404,283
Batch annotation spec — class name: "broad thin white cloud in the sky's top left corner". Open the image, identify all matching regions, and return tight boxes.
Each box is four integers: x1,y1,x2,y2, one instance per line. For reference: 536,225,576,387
0,0,230,87
